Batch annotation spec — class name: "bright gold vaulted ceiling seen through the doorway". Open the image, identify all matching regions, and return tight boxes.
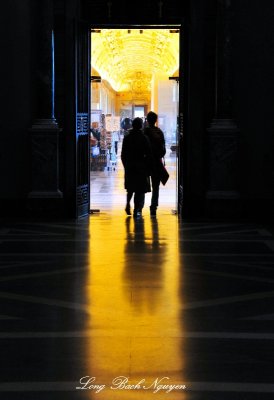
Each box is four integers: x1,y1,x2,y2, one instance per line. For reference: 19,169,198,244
91,29,179,92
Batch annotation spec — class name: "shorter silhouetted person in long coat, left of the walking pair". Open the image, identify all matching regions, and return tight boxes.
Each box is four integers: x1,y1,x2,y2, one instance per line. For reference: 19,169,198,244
121,117,152,218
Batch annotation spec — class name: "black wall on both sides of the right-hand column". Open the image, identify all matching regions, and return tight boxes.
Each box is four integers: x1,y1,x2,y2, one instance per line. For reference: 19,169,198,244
183,0,274,220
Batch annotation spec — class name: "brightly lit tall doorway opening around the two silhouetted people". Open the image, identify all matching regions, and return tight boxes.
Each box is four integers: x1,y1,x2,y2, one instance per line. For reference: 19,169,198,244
90,27,180,214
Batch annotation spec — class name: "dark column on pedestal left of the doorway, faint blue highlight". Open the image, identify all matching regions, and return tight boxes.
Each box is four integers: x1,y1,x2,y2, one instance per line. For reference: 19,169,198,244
29,0,62,199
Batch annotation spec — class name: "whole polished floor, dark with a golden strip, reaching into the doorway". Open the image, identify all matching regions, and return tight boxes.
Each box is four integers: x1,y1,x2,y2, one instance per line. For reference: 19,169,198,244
0,143,274,400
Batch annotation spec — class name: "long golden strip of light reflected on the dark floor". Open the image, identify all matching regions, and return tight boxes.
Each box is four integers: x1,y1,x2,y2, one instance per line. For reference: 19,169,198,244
85,214,186,400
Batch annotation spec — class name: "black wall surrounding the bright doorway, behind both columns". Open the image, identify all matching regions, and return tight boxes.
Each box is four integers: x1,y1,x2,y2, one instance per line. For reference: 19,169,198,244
0,0,274,218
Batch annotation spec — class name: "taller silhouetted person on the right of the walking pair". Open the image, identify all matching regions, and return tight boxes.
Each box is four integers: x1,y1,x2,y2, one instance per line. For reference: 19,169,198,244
144,111,166,216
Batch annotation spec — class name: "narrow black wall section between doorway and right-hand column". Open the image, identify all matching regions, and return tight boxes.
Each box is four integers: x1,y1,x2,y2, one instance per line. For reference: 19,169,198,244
182,0,216,218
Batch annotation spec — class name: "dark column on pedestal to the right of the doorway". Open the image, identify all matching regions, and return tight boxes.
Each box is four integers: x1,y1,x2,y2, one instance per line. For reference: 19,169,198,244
206,0,239,216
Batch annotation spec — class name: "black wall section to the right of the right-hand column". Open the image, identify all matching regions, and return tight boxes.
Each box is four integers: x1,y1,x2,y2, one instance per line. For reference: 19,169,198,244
233,0,274,217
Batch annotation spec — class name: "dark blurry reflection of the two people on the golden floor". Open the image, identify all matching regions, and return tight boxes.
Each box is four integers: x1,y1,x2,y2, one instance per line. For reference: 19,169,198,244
123,218,166,314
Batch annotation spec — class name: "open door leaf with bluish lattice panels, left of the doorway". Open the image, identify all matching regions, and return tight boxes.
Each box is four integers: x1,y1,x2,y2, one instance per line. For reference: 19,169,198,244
76,21,90,217
